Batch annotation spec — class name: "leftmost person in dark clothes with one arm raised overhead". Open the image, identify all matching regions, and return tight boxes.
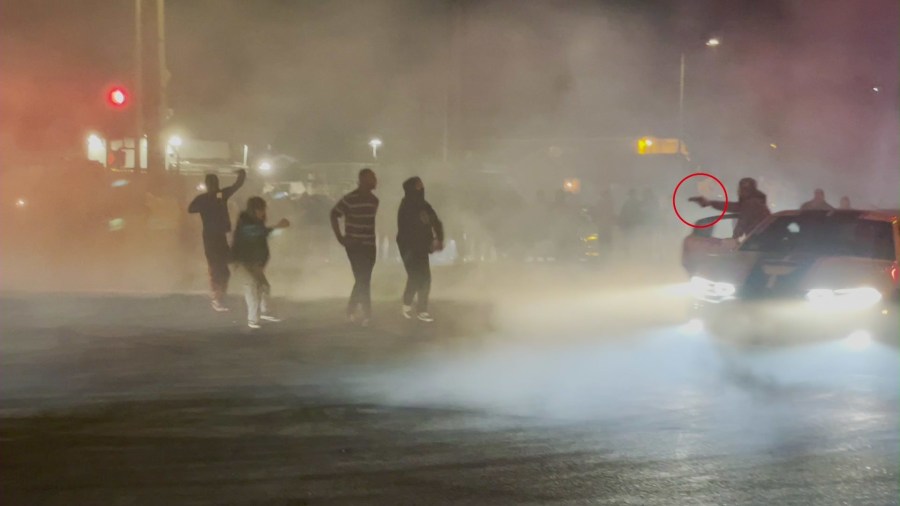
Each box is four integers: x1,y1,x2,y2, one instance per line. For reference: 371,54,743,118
188,169,247,311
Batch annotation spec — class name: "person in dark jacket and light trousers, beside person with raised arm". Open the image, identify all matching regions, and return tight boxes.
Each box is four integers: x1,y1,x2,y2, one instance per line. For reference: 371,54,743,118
232,197,290,329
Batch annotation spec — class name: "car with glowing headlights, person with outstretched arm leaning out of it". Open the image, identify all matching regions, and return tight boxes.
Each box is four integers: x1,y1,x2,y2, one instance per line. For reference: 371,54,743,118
683,210,900,344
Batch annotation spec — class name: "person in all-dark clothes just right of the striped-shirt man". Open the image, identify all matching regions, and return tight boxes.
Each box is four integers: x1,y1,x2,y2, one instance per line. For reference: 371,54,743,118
397,177,444,322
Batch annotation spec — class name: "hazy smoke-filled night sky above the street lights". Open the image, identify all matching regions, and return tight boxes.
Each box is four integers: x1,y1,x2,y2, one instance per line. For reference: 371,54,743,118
0,0,900,196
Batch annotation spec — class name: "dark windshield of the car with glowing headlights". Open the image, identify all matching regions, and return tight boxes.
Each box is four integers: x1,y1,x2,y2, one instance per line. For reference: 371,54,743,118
741,213,894,260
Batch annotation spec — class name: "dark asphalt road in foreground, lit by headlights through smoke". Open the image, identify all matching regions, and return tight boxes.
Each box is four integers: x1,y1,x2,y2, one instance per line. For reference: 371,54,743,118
0,288,900,506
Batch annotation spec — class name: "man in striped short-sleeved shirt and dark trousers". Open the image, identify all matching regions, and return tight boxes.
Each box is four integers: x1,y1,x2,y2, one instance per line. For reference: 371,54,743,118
331,169,378,326
